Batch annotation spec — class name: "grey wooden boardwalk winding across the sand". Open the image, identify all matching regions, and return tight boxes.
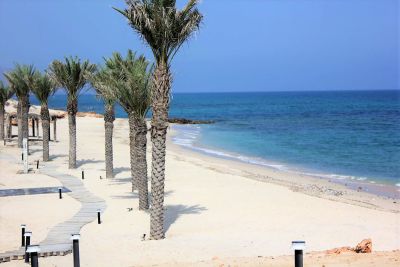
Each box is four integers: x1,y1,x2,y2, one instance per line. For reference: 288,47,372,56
0,155,106,263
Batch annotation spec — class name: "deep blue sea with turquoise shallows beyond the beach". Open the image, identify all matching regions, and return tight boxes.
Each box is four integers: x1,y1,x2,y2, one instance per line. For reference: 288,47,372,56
33,90,400,186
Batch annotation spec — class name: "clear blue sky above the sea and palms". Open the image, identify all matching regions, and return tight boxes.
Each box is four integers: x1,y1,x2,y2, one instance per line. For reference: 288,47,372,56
0,0,400,92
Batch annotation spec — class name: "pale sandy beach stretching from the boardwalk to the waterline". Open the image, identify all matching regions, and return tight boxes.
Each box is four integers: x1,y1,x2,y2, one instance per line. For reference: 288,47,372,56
0,113,400,266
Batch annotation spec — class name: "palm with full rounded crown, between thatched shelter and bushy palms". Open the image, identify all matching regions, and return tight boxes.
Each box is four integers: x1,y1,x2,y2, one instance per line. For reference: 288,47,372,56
48,57,96,169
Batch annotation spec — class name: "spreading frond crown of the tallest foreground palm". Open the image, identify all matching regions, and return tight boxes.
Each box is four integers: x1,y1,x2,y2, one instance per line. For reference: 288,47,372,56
114,0,203,64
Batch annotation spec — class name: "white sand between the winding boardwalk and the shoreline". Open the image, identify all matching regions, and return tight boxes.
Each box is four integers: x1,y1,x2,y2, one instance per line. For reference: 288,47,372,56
0,115,400,266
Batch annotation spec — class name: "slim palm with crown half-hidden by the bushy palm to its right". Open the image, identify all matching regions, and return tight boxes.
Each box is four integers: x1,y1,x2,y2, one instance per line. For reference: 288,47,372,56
88,70,115,178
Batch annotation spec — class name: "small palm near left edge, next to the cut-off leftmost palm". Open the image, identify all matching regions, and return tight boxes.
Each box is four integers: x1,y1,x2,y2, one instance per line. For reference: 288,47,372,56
4,64,35,147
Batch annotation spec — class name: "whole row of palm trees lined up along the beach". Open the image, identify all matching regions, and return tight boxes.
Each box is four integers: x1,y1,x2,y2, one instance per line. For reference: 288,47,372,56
0,0,203,240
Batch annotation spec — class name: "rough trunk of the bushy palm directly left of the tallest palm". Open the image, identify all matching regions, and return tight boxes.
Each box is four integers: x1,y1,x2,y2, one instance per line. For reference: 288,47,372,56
134,118,149,210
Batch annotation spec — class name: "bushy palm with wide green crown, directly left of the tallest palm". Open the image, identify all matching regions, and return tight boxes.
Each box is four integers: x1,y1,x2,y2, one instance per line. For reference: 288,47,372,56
90,50,151,210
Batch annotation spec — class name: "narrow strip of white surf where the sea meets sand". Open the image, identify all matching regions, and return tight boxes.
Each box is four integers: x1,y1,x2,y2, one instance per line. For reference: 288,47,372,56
170,124,400,200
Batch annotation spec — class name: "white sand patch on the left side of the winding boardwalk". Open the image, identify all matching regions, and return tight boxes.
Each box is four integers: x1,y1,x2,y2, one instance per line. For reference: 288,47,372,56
0,160,81,252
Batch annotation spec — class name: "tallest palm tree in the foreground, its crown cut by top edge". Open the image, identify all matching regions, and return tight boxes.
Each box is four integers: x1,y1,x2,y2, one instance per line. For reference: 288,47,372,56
116,0,203,239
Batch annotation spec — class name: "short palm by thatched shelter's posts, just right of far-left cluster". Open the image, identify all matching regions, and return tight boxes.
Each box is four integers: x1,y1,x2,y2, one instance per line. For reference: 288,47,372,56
32,72,56,161
